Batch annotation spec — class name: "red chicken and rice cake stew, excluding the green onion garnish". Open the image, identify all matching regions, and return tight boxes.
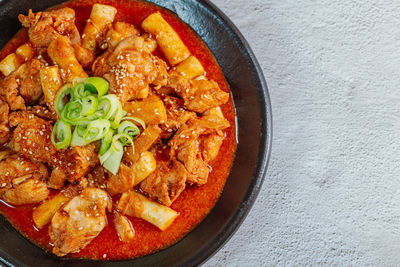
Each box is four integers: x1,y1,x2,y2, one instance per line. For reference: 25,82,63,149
0,0,236,259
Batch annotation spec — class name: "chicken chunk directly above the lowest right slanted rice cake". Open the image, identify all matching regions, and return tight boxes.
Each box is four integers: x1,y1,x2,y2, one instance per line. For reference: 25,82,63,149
140,161,187,206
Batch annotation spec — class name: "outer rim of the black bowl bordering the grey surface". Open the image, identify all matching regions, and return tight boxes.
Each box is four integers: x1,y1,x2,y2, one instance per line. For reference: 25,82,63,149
184,0,273,266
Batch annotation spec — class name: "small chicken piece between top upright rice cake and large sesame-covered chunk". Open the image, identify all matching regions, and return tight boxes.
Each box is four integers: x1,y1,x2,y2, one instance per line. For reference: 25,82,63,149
100,21,139,49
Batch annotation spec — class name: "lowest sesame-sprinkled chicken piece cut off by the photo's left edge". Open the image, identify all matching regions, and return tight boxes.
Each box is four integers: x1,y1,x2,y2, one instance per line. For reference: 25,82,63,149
0,155,49,205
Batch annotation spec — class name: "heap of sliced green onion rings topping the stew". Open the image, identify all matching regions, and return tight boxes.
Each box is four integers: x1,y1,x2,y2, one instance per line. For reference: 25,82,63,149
51,77,146,174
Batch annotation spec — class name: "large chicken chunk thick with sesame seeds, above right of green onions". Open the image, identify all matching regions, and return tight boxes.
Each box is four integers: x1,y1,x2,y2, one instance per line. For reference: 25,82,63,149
93,37,167,103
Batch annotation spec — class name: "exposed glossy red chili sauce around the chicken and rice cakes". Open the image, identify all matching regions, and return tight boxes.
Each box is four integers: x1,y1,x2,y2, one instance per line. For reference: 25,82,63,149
0,0,236,260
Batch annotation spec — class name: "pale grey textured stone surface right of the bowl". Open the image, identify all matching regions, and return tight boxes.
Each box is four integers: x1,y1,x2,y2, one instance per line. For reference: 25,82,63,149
204,0,400,266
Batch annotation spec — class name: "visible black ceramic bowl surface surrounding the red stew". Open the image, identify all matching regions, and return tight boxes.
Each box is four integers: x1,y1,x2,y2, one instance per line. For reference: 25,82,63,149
0,0,272,267
